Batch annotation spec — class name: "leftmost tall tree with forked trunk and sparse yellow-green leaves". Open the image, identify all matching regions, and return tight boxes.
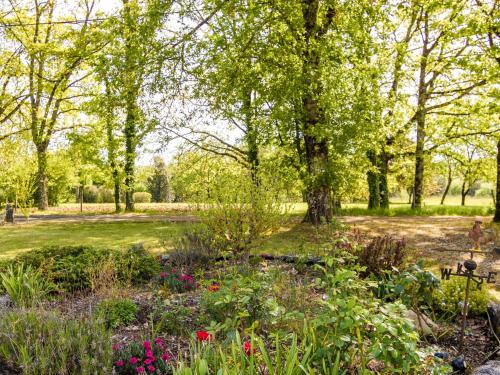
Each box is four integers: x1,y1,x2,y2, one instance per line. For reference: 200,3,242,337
2,0,102,210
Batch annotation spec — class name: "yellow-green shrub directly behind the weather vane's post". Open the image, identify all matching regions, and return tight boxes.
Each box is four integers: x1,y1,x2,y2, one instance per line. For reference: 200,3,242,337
433,277,489,316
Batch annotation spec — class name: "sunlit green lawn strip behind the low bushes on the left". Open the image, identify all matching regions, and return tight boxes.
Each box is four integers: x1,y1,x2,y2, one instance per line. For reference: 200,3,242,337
0,221,192,259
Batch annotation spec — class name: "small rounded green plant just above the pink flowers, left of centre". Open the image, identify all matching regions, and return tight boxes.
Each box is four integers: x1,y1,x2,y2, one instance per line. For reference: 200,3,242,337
95,298,138,328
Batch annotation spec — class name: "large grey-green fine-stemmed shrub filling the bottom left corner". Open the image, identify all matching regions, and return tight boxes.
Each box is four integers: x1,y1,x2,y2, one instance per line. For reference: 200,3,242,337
0,310,112,375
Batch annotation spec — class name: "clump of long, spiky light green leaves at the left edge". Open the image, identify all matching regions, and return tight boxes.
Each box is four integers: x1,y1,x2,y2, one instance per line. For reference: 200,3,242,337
0,264,54,307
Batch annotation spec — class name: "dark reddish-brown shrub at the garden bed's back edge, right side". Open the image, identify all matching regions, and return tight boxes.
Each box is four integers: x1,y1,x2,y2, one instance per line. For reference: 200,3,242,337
357,235,406,276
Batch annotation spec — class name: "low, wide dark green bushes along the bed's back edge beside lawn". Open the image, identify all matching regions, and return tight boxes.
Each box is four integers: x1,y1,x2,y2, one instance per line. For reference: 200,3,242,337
9,245,160,292
